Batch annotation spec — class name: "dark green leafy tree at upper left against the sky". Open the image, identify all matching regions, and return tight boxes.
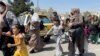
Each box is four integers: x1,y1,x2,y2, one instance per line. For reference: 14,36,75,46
11,0,34,16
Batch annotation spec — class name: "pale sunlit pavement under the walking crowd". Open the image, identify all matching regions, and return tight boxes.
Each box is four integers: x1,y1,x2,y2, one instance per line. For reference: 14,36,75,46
0,41,100,56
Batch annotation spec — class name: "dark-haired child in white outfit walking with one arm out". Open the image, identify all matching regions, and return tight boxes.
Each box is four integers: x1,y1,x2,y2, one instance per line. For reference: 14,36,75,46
45,19,63,56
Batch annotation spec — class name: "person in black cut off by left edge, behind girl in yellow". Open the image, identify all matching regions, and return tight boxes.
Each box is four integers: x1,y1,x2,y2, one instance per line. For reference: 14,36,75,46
0,2,14,56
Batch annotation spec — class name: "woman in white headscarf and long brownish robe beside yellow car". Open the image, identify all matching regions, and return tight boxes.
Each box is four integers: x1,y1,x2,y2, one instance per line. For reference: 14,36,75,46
29,13,44,53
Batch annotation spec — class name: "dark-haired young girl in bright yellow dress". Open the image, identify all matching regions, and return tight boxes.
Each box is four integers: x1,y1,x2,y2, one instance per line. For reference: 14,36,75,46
3,24,28,56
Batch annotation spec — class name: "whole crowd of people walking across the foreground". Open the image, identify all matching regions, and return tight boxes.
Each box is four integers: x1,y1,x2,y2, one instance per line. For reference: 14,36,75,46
0,2,100,56
